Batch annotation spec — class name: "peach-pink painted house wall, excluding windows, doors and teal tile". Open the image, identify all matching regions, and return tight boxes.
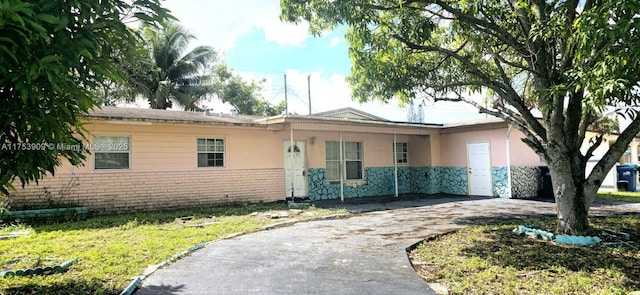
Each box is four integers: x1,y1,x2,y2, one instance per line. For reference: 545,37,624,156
5,112,552,212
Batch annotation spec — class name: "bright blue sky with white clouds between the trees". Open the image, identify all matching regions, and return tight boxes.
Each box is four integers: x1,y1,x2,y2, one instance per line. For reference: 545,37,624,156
162,0,482,123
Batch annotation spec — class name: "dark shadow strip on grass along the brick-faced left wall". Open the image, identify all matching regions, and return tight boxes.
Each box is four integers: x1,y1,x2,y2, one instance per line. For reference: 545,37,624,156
5,203,288,232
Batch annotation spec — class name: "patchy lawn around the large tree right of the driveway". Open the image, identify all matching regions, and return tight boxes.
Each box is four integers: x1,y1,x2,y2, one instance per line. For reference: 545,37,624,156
410,216,640,295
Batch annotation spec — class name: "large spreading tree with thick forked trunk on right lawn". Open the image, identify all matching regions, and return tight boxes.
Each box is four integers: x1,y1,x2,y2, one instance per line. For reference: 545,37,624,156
281,0,640,233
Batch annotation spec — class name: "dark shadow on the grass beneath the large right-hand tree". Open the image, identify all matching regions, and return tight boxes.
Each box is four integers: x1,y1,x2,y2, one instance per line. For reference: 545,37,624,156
461,217,640,290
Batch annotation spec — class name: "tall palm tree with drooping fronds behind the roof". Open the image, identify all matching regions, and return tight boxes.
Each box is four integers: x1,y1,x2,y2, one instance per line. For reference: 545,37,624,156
137,22,216,110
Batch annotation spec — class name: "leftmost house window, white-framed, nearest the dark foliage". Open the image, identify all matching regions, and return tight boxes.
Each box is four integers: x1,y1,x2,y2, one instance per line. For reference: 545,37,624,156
93,136,131,169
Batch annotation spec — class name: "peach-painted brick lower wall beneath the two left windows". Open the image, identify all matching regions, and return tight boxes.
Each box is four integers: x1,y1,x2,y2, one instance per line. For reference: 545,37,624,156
9,169,285,214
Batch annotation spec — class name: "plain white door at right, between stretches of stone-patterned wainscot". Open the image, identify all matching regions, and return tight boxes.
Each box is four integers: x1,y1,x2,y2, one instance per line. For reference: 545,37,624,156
467,142,493,196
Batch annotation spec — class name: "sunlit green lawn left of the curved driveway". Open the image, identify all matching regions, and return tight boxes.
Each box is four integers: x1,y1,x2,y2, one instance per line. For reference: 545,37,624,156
0,204,346,294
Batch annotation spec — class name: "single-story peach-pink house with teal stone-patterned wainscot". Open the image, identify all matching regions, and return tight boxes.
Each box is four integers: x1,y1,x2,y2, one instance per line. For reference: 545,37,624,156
10,107,556,213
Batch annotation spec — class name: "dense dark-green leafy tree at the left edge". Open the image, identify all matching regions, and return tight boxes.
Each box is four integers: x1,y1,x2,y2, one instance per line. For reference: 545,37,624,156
0,0,170,194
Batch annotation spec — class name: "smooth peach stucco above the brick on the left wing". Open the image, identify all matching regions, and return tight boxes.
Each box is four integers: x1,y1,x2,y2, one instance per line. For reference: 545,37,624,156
57,120,283,173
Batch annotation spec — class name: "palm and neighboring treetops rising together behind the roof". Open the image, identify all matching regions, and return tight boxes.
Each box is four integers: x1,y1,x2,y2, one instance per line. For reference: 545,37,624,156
103,21,285,116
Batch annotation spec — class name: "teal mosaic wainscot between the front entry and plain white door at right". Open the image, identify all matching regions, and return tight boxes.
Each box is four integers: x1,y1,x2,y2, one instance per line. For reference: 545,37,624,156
307,167,468,200
